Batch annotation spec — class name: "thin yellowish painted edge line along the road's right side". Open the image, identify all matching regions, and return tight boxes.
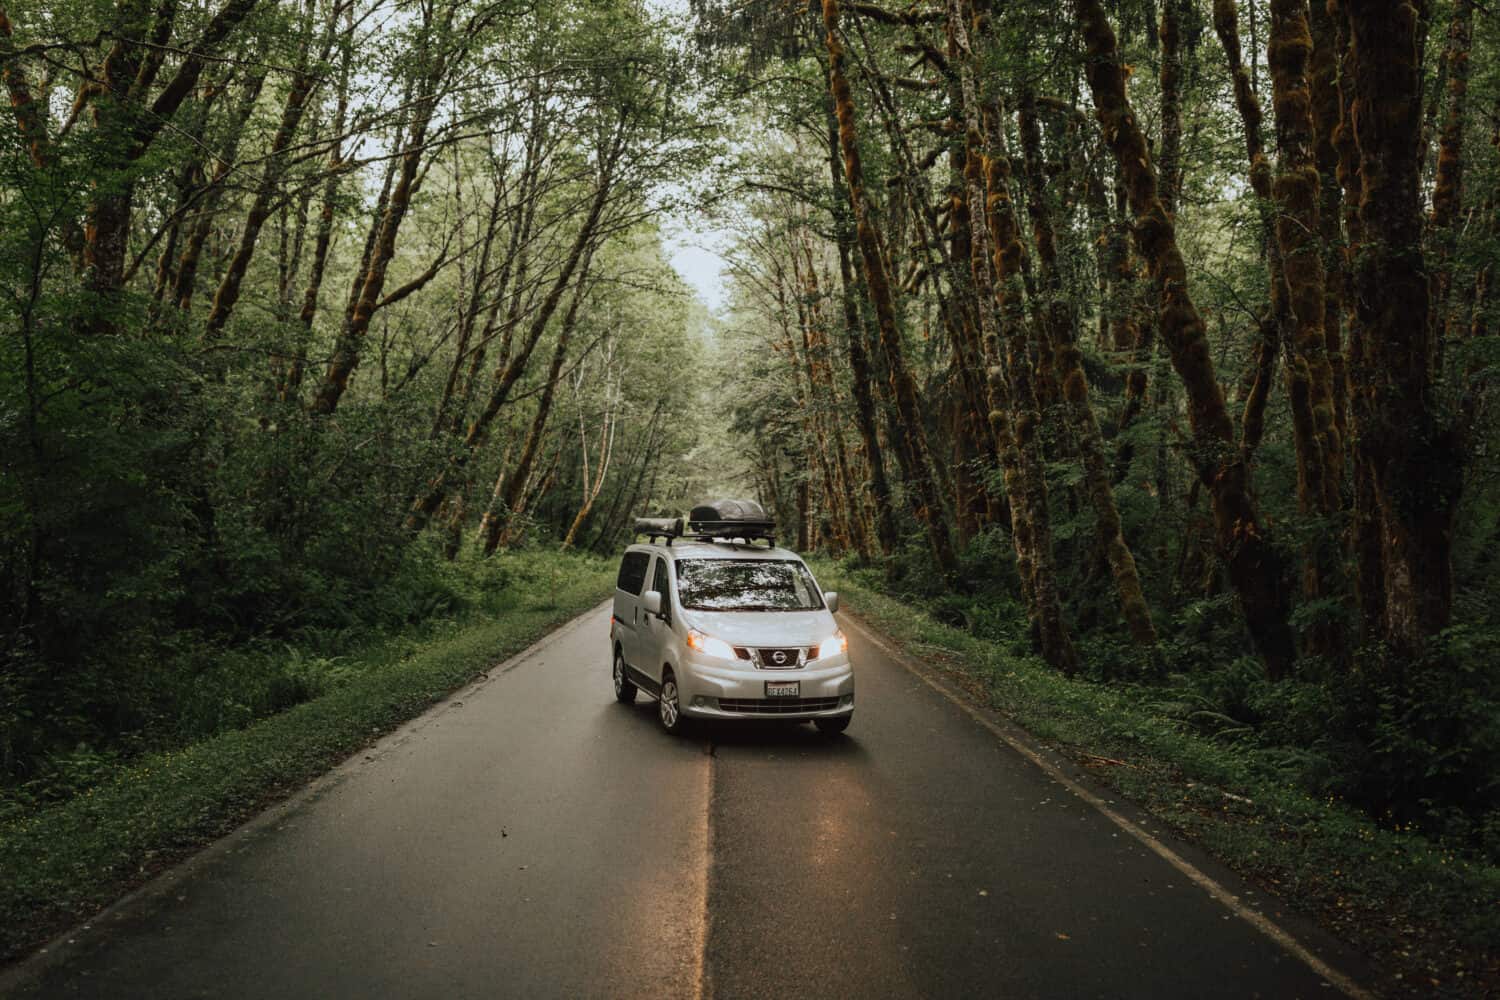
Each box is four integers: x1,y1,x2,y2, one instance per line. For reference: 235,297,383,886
845,616,1376,1000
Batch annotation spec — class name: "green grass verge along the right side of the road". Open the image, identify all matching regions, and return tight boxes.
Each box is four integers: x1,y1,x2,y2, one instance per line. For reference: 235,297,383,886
813,561,1500,997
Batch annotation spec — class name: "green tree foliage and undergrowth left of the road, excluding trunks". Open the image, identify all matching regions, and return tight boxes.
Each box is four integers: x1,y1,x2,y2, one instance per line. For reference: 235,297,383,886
0,0,717,807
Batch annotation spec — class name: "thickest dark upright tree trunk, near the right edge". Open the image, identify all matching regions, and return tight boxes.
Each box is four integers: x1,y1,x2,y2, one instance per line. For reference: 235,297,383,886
1344,0,1463,660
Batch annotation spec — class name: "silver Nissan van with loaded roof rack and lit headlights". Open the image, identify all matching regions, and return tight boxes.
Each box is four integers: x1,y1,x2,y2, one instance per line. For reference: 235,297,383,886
609,501,854,733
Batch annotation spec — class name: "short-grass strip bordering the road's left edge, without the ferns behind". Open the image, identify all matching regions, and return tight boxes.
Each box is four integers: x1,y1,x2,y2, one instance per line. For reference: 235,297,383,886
0,553,615,963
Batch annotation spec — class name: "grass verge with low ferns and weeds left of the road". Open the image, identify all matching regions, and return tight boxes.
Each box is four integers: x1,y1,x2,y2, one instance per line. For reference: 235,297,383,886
0,550,617,961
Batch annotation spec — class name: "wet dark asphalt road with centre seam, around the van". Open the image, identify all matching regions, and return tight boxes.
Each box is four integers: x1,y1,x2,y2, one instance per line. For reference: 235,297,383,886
0,607,1368,1000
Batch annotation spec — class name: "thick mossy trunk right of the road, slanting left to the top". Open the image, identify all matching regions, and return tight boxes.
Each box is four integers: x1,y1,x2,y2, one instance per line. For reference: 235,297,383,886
1074,0,1296,678
